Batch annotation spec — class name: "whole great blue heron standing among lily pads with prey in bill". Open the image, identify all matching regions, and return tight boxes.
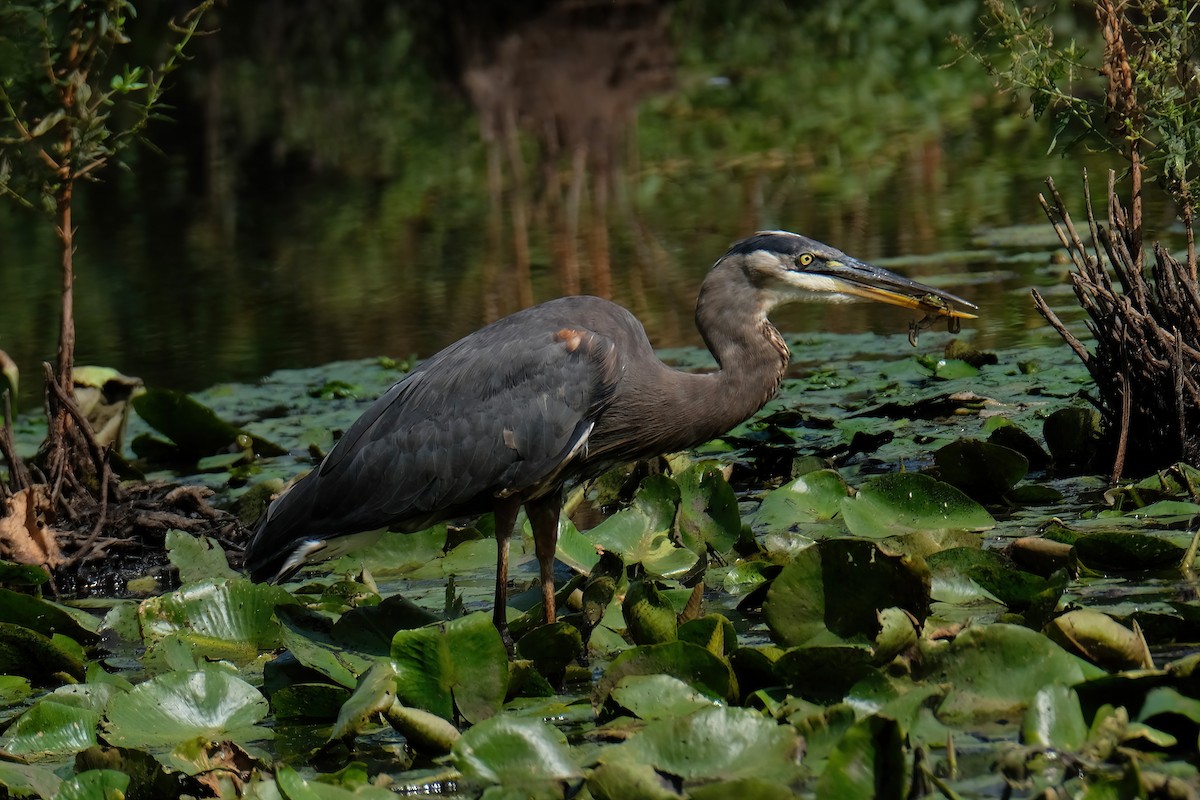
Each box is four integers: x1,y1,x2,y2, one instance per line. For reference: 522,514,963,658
246,231,974,632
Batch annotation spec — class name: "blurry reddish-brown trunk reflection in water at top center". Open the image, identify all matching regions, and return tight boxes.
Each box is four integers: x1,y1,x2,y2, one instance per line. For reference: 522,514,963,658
451,0,673,306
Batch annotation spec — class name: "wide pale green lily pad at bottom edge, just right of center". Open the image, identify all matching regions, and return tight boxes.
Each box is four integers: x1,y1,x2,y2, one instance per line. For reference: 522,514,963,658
600,706,800,786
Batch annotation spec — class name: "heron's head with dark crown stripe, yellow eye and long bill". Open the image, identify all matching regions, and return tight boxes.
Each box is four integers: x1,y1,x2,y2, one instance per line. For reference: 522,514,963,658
718,230,976,319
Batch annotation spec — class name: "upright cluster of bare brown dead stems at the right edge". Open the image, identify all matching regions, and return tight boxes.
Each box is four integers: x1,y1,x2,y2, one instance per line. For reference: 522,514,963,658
1033,173,1200,481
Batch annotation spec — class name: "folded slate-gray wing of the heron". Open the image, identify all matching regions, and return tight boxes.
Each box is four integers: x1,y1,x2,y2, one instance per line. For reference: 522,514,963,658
252,316,620,549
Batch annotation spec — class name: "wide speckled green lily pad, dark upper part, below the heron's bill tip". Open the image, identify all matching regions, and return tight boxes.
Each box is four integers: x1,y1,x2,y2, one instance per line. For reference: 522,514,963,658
841,473,996,539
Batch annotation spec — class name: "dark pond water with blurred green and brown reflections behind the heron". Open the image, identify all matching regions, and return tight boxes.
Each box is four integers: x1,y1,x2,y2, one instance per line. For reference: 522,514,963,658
0,0,1123,400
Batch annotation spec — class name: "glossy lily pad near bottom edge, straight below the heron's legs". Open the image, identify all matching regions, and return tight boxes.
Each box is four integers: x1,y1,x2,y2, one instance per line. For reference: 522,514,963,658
451,715,583,787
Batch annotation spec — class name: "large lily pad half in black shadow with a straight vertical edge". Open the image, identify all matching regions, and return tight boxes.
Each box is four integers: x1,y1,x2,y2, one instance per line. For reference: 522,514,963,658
763,539,930,646
